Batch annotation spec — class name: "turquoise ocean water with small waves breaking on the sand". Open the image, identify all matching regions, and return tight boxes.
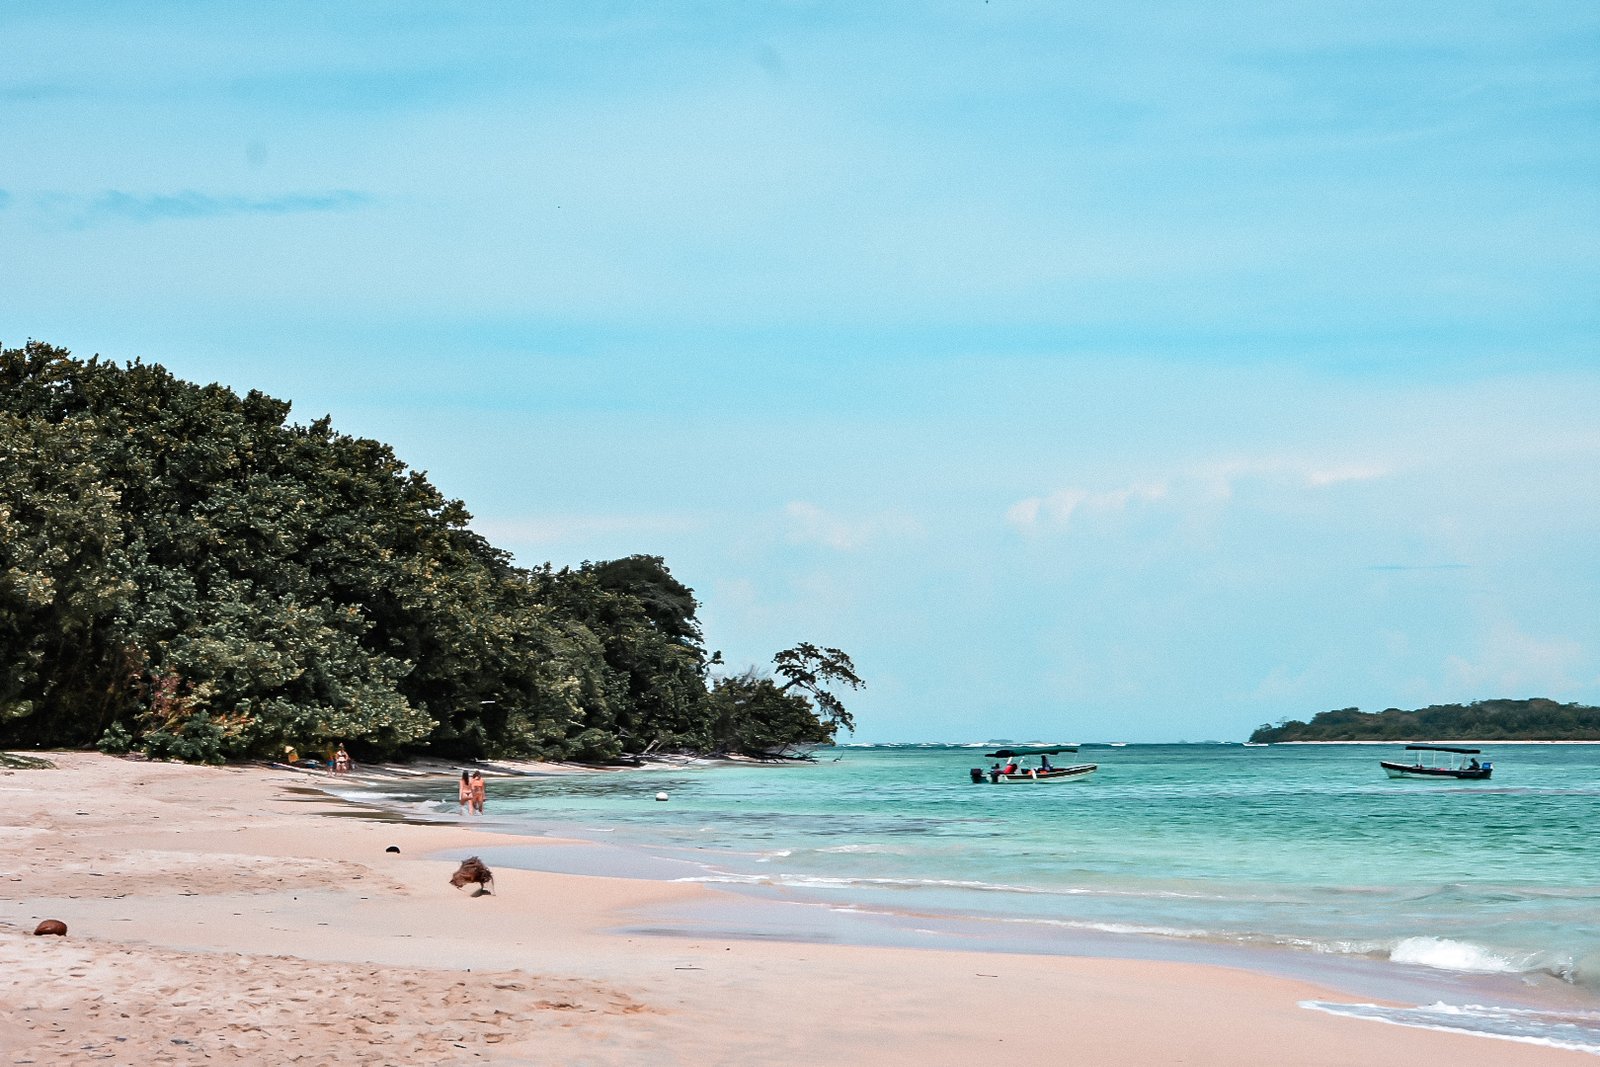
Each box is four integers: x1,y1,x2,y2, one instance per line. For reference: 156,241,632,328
341,742,1600,1054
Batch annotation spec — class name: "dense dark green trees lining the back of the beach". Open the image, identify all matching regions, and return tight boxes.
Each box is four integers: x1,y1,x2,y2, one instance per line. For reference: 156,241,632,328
0,342,861,761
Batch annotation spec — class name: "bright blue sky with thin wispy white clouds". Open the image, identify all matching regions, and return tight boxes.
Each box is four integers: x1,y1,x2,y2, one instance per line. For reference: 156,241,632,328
0,0,1600,742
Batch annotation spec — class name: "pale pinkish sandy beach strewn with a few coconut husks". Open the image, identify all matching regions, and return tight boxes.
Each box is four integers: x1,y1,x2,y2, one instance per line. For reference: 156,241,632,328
0,753,1595,1067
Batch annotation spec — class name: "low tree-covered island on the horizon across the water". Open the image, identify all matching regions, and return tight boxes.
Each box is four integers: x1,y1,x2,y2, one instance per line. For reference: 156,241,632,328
1250,697,1600,742
